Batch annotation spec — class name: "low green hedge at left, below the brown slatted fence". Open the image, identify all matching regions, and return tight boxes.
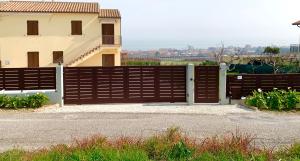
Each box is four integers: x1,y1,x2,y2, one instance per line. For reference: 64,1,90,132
0,94,49,109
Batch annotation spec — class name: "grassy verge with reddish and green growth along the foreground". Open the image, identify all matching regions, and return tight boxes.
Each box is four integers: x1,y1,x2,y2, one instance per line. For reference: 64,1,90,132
0,128,300,161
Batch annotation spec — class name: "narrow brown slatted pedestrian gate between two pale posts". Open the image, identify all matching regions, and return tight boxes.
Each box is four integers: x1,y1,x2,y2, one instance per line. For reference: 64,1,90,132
195,66,219,103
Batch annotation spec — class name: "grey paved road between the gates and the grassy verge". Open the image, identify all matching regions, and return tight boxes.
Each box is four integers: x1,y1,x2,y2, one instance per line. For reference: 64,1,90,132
0,112,300,151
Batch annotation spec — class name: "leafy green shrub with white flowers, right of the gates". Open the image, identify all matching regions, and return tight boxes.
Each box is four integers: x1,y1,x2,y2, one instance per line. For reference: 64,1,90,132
246,89,300,110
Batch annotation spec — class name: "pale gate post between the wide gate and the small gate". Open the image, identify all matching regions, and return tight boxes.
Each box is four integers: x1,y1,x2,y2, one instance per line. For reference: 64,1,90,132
186,64,195,105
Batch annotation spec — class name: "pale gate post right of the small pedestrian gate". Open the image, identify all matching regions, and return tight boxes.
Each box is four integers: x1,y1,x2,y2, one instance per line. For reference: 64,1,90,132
219,63,229,105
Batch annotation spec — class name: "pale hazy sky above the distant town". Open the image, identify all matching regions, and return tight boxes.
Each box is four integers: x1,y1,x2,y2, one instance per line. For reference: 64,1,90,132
79,0,300,50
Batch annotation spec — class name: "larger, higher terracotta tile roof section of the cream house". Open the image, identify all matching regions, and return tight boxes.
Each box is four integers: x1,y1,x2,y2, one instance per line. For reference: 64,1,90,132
0,1,99,13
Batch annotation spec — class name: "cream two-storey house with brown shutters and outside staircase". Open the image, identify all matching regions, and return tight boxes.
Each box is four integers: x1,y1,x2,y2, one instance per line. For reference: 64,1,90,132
0,1,122,68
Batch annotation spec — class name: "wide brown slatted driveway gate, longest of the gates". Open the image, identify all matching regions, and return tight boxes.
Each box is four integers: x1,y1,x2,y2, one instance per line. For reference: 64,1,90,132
64,66,186,104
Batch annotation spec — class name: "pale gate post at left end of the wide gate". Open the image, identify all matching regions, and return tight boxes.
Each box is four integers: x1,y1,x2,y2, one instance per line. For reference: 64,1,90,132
55,64,64,107
